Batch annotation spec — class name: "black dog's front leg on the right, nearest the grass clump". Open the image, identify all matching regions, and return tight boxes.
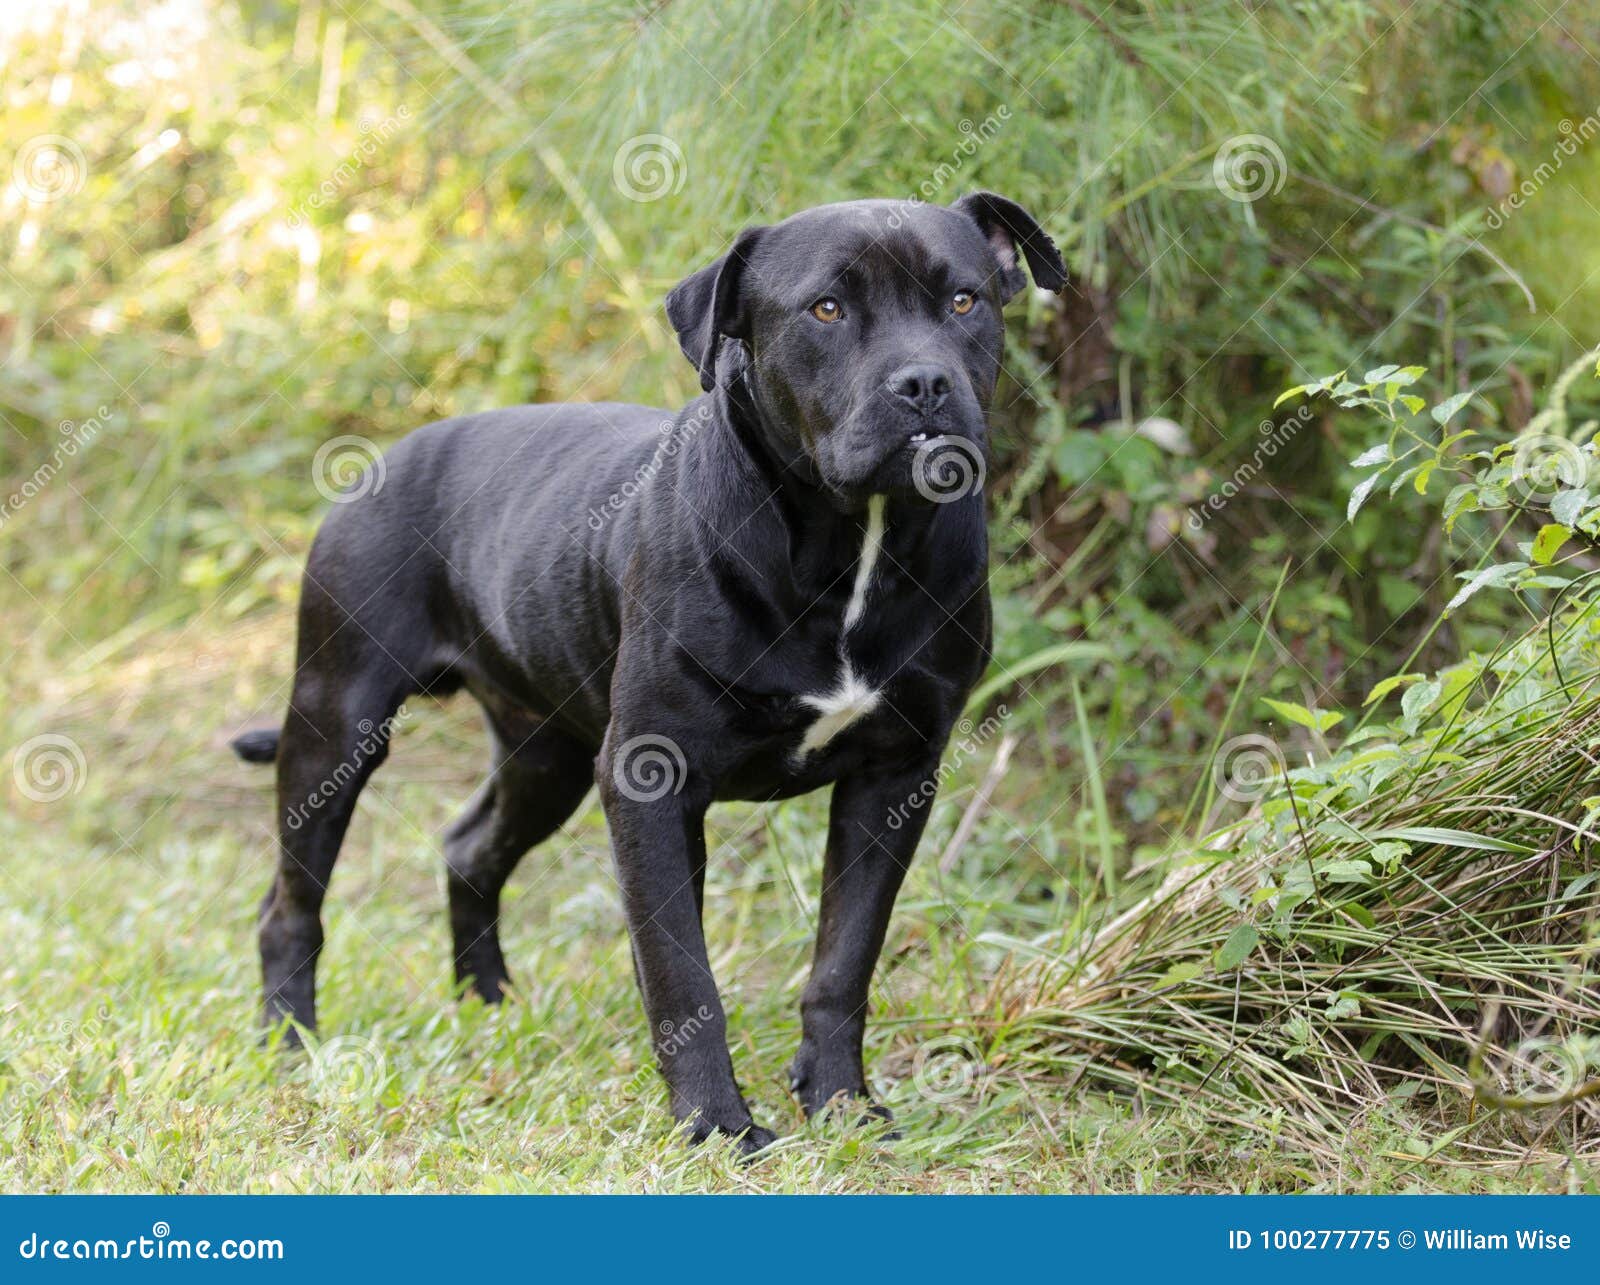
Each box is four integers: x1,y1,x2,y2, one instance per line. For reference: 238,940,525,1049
789,757,938,1120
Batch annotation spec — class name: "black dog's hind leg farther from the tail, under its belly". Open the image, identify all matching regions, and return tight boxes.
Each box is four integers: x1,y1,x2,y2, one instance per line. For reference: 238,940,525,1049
445,715,594,1003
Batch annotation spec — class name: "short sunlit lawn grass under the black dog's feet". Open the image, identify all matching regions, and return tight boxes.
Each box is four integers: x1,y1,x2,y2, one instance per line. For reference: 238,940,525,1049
0,613,1592,1192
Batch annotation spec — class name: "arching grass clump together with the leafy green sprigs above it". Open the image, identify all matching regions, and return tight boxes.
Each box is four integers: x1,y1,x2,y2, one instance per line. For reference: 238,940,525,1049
994,354,1600,1160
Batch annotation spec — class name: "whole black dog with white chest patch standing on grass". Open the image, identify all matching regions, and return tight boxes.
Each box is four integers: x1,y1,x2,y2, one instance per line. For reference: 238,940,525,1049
235,192,1066,1152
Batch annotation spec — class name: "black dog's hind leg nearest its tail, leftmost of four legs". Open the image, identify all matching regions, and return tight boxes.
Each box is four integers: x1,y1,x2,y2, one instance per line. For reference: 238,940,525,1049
259,601,411,1043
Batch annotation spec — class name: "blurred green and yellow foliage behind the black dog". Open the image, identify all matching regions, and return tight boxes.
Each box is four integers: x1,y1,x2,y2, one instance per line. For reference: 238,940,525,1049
9,0,1600,1181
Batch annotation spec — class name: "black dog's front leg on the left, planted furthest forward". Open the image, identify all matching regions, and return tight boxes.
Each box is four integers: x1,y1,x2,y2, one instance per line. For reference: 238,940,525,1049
597,727,776,1154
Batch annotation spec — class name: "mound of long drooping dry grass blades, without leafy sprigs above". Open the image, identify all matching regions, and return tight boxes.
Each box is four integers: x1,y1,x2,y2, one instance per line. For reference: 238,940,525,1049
1003,643,1600,1178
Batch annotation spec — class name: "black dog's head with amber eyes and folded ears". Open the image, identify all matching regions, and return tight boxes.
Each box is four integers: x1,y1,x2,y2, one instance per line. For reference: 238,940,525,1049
667,192,1066,502
